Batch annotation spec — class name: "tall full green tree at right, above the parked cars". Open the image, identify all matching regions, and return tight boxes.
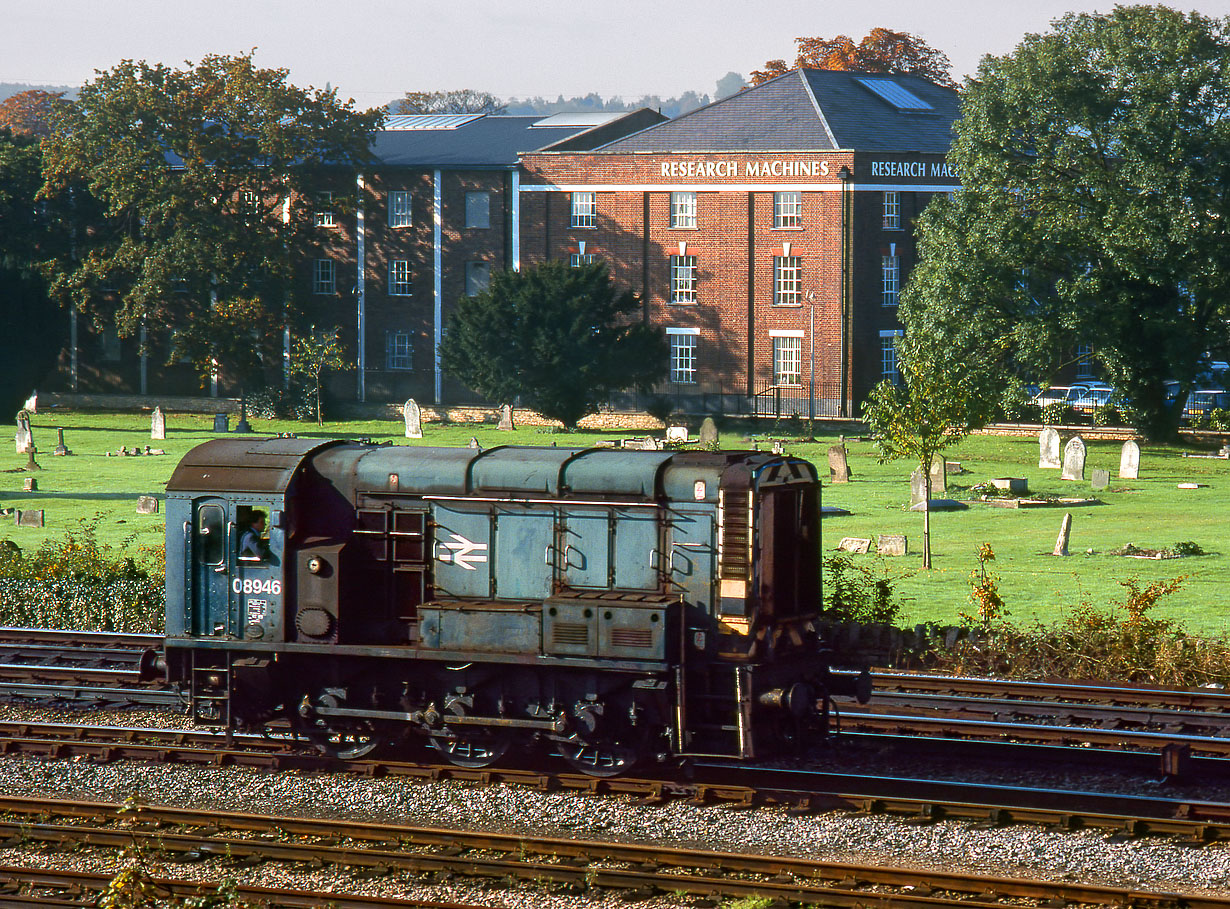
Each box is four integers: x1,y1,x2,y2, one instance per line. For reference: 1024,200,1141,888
900,6,1230,439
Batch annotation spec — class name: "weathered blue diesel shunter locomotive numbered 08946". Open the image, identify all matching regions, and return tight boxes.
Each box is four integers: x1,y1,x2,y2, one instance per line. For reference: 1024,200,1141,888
156,438,868,776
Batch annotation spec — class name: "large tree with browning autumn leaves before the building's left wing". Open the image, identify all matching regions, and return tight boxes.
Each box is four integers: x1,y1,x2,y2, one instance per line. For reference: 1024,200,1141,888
42,54,384,389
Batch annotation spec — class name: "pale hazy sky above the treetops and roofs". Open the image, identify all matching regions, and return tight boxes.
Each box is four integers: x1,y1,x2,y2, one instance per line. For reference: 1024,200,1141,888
7,0,1230,107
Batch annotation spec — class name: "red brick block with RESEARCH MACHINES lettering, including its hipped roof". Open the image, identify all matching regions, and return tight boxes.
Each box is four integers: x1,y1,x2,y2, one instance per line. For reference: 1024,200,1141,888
520,70,958,415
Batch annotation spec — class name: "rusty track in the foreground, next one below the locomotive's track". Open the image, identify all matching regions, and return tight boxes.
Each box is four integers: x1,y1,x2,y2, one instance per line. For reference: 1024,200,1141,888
0,797,1230,909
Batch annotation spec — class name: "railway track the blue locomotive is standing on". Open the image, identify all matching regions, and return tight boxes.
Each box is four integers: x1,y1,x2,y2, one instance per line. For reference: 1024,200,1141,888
0,723,1230,844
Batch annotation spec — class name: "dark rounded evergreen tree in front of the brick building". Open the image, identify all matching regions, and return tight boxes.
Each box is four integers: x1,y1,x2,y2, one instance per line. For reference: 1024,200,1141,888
440,262,667,428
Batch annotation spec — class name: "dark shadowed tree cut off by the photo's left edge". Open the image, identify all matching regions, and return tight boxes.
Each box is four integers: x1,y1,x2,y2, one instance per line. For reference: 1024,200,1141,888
0,129,65,415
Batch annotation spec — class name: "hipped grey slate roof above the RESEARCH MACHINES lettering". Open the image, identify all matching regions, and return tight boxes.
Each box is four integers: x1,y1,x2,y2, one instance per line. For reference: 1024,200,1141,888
599,69,961,155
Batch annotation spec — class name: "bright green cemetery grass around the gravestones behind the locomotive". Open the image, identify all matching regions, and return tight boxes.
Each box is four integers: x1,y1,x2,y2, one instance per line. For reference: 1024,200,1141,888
0,411,1230,636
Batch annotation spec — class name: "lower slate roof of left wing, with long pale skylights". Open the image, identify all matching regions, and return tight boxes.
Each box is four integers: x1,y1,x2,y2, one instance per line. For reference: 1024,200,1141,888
371,111,659,170
